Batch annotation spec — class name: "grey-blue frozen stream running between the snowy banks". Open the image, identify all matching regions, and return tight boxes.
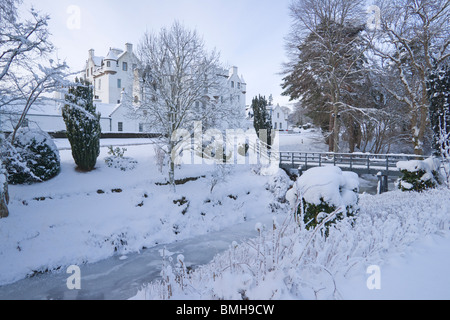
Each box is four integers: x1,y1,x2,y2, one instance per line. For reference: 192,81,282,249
0,216,272,300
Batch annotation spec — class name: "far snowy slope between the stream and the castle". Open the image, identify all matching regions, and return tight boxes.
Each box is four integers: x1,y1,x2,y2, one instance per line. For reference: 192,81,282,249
0,141,292,285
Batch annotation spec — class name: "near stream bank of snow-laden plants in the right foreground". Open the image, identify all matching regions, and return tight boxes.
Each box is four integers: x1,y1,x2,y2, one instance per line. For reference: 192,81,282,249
133,189,450,300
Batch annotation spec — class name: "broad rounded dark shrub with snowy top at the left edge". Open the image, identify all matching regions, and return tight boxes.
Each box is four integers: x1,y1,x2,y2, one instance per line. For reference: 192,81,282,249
2,128,61,184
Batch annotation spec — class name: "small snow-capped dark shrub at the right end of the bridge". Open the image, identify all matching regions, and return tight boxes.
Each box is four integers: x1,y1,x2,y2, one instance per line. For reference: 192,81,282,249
397,157,441,192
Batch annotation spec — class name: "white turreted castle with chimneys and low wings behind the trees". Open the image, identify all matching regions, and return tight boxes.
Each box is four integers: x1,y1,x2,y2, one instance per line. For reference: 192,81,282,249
0,43,247,133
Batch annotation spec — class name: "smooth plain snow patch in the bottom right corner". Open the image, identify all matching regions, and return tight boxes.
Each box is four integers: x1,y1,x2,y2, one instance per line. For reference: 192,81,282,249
337,232,450,300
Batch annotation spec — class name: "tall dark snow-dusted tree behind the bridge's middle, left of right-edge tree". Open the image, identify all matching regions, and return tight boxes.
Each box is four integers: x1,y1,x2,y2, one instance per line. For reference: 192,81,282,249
283,0,369,152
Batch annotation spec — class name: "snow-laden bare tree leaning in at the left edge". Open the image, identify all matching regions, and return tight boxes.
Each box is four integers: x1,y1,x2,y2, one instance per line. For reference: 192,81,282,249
0,0,68,217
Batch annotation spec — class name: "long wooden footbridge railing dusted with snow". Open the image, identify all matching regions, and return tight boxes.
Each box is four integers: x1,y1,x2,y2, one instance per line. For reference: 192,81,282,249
280,151,424,173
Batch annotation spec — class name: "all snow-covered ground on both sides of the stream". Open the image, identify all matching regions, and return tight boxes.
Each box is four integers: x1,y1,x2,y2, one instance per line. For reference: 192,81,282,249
0,132,450,299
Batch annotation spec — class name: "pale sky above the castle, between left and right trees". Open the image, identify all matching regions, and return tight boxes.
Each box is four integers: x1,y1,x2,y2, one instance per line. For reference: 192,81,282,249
24,0,291,106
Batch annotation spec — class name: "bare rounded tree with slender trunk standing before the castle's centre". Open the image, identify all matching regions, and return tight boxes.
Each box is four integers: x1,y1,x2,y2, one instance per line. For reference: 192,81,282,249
135,22,239,186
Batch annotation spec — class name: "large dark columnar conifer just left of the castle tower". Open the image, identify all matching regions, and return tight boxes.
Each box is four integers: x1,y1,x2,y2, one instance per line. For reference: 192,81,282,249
63,78,101,171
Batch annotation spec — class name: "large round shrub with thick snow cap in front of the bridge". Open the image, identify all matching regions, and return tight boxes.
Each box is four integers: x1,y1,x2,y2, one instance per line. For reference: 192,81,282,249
286,166,359,234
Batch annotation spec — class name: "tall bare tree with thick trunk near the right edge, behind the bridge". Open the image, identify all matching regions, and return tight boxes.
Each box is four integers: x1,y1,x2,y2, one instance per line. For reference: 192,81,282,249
374,0,450,155
